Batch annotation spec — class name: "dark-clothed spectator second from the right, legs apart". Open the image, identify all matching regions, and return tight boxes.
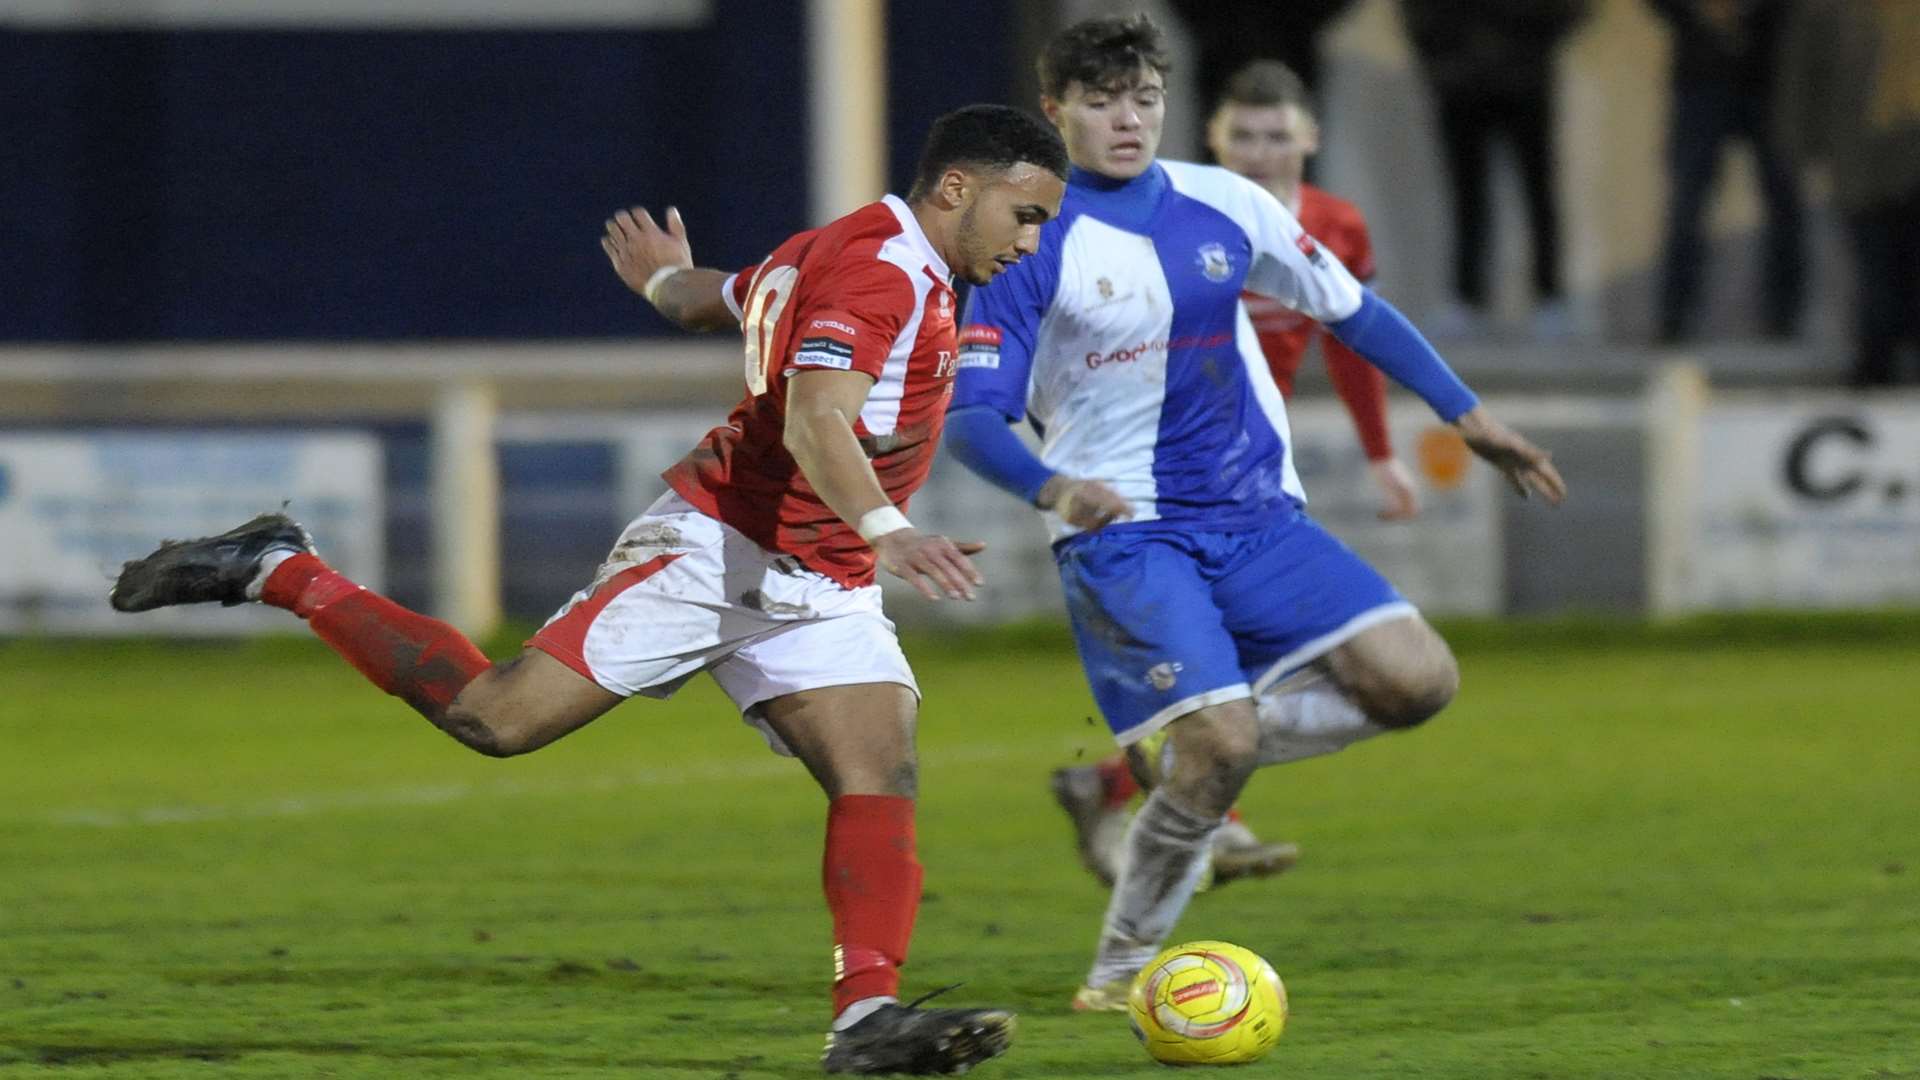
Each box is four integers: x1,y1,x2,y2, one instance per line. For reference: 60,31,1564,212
1647,0,1804,344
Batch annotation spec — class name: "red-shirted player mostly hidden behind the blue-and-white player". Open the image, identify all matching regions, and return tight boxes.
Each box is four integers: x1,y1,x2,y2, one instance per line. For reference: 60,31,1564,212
1052,60,1419,884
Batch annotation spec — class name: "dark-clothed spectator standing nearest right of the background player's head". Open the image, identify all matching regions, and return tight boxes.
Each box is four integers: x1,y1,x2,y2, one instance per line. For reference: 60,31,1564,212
1400,0,1588,336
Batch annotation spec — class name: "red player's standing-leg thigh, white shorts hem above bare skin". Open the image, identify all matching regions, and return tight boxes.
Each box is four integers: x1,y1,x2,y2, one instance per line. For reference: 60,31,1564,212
712,611,920,796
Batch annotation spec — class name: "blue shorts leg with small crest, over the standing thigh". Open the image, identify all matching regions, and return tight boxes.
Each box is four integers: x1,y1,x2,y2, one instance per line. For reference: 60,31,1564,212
1058,528,1252,746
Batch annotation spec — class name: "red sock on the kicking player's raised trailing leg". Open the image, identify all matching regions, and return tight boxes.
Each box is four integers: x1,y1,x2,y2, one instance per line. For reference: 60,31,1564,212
259,553,492,721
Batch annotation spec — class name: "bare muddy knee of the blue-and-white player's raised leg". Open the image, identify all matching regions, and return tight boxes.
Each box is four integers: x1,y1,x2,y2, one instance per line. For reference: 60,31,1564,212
1327,613,1459,728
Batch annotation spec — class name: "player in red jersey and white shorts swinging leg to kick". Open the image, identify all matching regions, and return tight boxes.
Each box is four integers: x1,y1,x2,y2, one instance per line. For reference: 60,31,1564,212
111,106,1068,1074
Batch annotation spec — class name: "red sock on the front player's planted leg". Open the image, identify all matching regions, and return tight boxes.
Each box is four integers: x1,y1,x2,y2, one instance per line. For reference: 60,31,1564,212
822,796,920,1017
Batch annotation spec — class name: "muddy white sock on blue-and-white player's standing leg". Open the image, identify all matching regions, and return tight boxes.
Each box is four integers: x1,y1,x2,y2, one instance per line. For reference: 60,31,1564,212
1087,788,1221,986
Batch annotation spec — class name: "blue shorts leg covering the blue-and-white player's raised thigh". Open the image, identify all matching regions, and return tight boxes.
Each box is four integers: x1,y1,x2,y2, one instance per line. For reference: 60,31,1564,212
1213,515,1425,692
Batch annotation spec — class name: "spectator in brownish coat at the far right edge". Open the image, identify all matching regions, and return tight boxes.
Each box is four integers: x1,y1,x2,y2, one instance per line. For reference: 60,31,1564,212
1776,0,1920,386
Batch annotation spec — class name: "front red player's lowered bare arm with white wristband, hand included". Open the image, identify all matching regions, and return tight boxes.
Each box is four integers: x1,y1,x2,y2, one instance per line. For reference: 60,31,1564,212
783,369,987,600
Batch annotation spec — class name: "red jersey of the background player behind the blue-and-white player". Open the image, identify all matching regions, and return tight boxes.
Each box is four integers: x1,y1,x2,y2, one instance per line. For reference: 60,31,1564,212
1240,184,1394,461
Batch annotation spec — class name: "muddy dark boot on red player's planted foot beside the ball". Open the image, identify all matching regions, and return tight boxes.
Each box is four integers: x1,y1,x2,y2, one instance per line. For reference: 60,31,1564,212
822,992,1014,1076
